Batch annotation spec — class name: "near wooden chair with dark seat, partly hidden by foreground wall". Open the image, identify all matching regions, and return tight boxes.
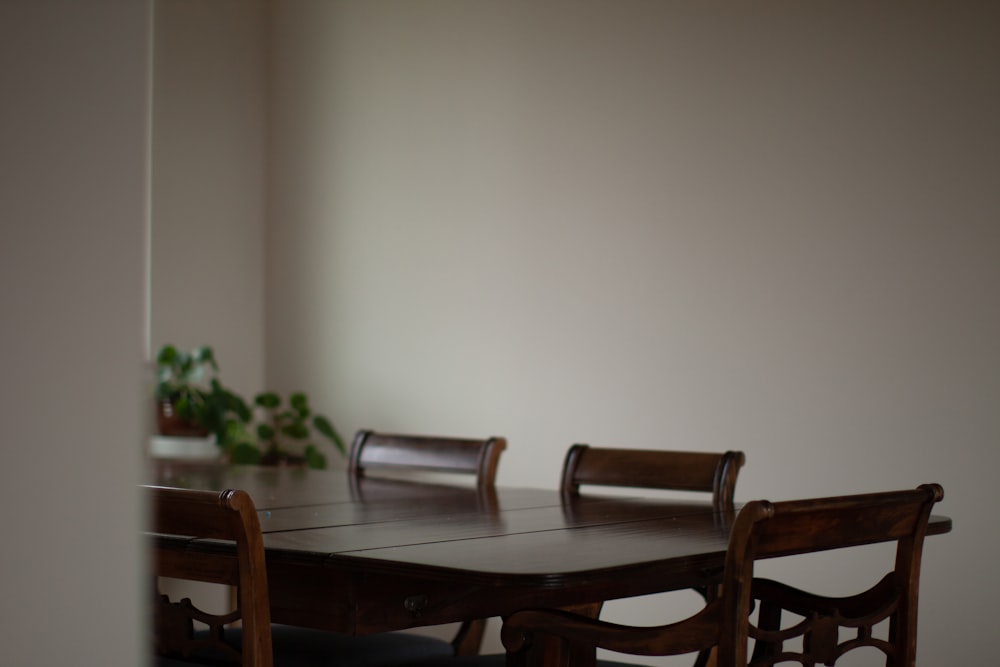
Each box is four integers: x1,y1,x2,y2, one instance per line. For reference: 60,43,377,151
146,487,464,667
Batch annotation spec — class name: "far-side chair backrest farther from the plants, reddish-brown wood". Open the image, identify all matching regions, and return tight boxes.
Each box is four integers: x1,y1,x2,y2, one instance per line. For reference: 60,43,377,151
560,444,746,508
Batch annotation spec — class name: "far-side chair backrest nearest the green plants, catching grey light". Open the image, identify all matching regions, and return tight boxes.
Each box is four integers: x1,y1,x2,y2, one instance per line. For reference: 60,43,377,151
348,430,507,489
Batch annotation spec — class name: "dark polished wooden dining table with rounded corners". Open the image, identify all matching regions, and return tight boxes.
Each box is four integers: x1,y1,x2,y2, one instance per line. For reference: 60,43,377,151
149,461,951,656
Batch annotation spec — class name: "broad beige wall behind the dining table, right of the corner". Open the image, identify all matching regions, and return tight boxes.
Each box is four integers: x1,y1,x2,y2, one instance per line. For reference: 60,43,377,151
265,1,1000,664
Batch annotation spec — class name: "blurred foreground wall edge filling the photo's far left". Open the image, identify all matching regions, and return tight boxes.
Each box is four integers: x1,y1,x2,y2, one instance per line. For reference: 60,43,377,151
0,0,150,667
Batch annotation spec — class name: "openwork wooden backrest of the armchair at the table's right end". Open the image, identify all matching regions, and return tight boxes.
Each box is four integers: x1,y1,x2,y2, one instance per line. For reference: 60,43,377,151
720,484,944,667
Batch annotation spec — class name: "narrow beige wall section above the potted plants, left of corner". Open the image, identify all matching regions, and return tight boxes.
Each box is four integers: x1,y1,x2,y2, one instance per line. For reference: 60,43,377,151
151,0,267,395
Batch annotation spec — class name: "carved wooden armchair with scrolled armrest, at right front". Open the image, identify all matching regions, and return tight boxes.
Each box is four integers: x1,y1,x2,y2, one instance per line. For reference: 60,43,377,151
500,484,944,667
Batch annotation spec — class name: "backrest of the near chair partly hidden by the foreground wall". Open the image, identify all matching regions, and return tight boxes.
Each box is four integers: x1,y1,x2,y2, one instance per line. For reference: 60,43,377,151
143,486,273,667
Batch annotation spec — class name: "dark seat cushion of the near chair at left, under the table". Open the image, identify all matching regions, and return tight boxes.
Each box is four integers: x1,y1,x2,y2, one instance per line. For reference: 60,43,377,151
217,624,455,667
